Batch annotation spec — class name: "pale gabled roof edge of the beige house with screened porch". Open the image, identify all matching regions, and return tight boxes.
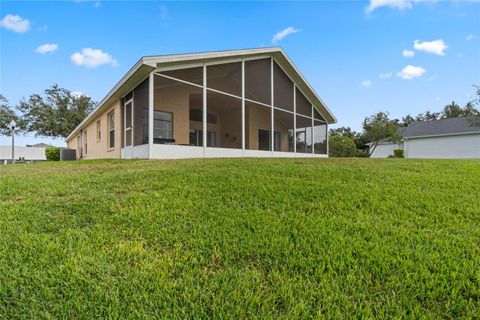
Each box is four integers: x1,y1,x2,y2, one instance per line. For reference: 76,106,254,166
66,47,337,141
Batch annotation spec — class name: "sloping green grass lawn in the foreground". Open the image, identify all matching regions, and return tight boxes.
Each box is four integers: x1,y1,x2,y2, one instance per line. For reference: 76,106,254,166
0,159,480,319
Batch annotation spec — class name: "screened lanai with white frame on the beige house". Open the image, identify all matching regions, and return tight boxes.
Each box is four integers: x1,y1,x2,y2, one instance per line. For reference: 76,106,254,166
121,53,327,158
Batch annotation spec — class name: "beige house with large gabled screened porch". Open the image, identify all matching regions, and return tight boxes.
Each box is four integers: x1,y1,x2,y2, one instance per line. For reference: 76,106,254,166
66,47,336,159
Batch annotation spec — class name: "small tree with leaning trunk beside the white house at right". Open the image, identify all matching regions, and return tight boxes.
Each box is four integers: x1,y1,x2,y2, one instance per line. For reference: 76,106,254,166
363,112,402,156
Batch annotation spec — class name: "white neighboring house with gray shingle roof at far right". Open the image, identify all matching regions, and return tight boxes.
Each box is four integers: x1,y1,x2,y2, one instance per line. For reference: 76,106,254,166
371,118,480,158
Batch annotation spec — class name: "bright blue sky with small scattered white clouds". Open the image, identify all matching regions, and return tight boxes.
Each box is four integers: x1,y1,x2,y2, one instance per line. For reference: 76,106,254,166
0,0,480,145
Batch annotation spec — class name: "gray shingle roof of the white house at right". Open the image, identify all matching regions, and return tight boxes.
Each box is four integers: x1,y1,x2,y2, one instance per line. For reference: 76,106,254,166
402,118,480,138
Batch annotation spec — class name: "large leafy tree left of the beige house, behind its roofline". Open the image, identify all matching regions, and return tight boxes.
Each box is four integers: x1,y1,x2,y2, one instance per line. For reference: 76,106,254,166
18,85,95,138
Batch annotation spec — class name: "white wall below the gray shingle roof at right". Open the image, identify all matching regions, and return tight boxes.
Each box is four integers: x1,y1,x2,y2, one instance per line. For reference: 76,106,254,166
405,134,480,159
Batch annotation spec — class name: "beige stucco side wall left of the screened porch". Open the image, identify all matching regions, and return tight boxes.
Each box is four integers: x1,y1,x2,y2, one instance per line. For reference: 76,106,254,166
67,100,122,159
